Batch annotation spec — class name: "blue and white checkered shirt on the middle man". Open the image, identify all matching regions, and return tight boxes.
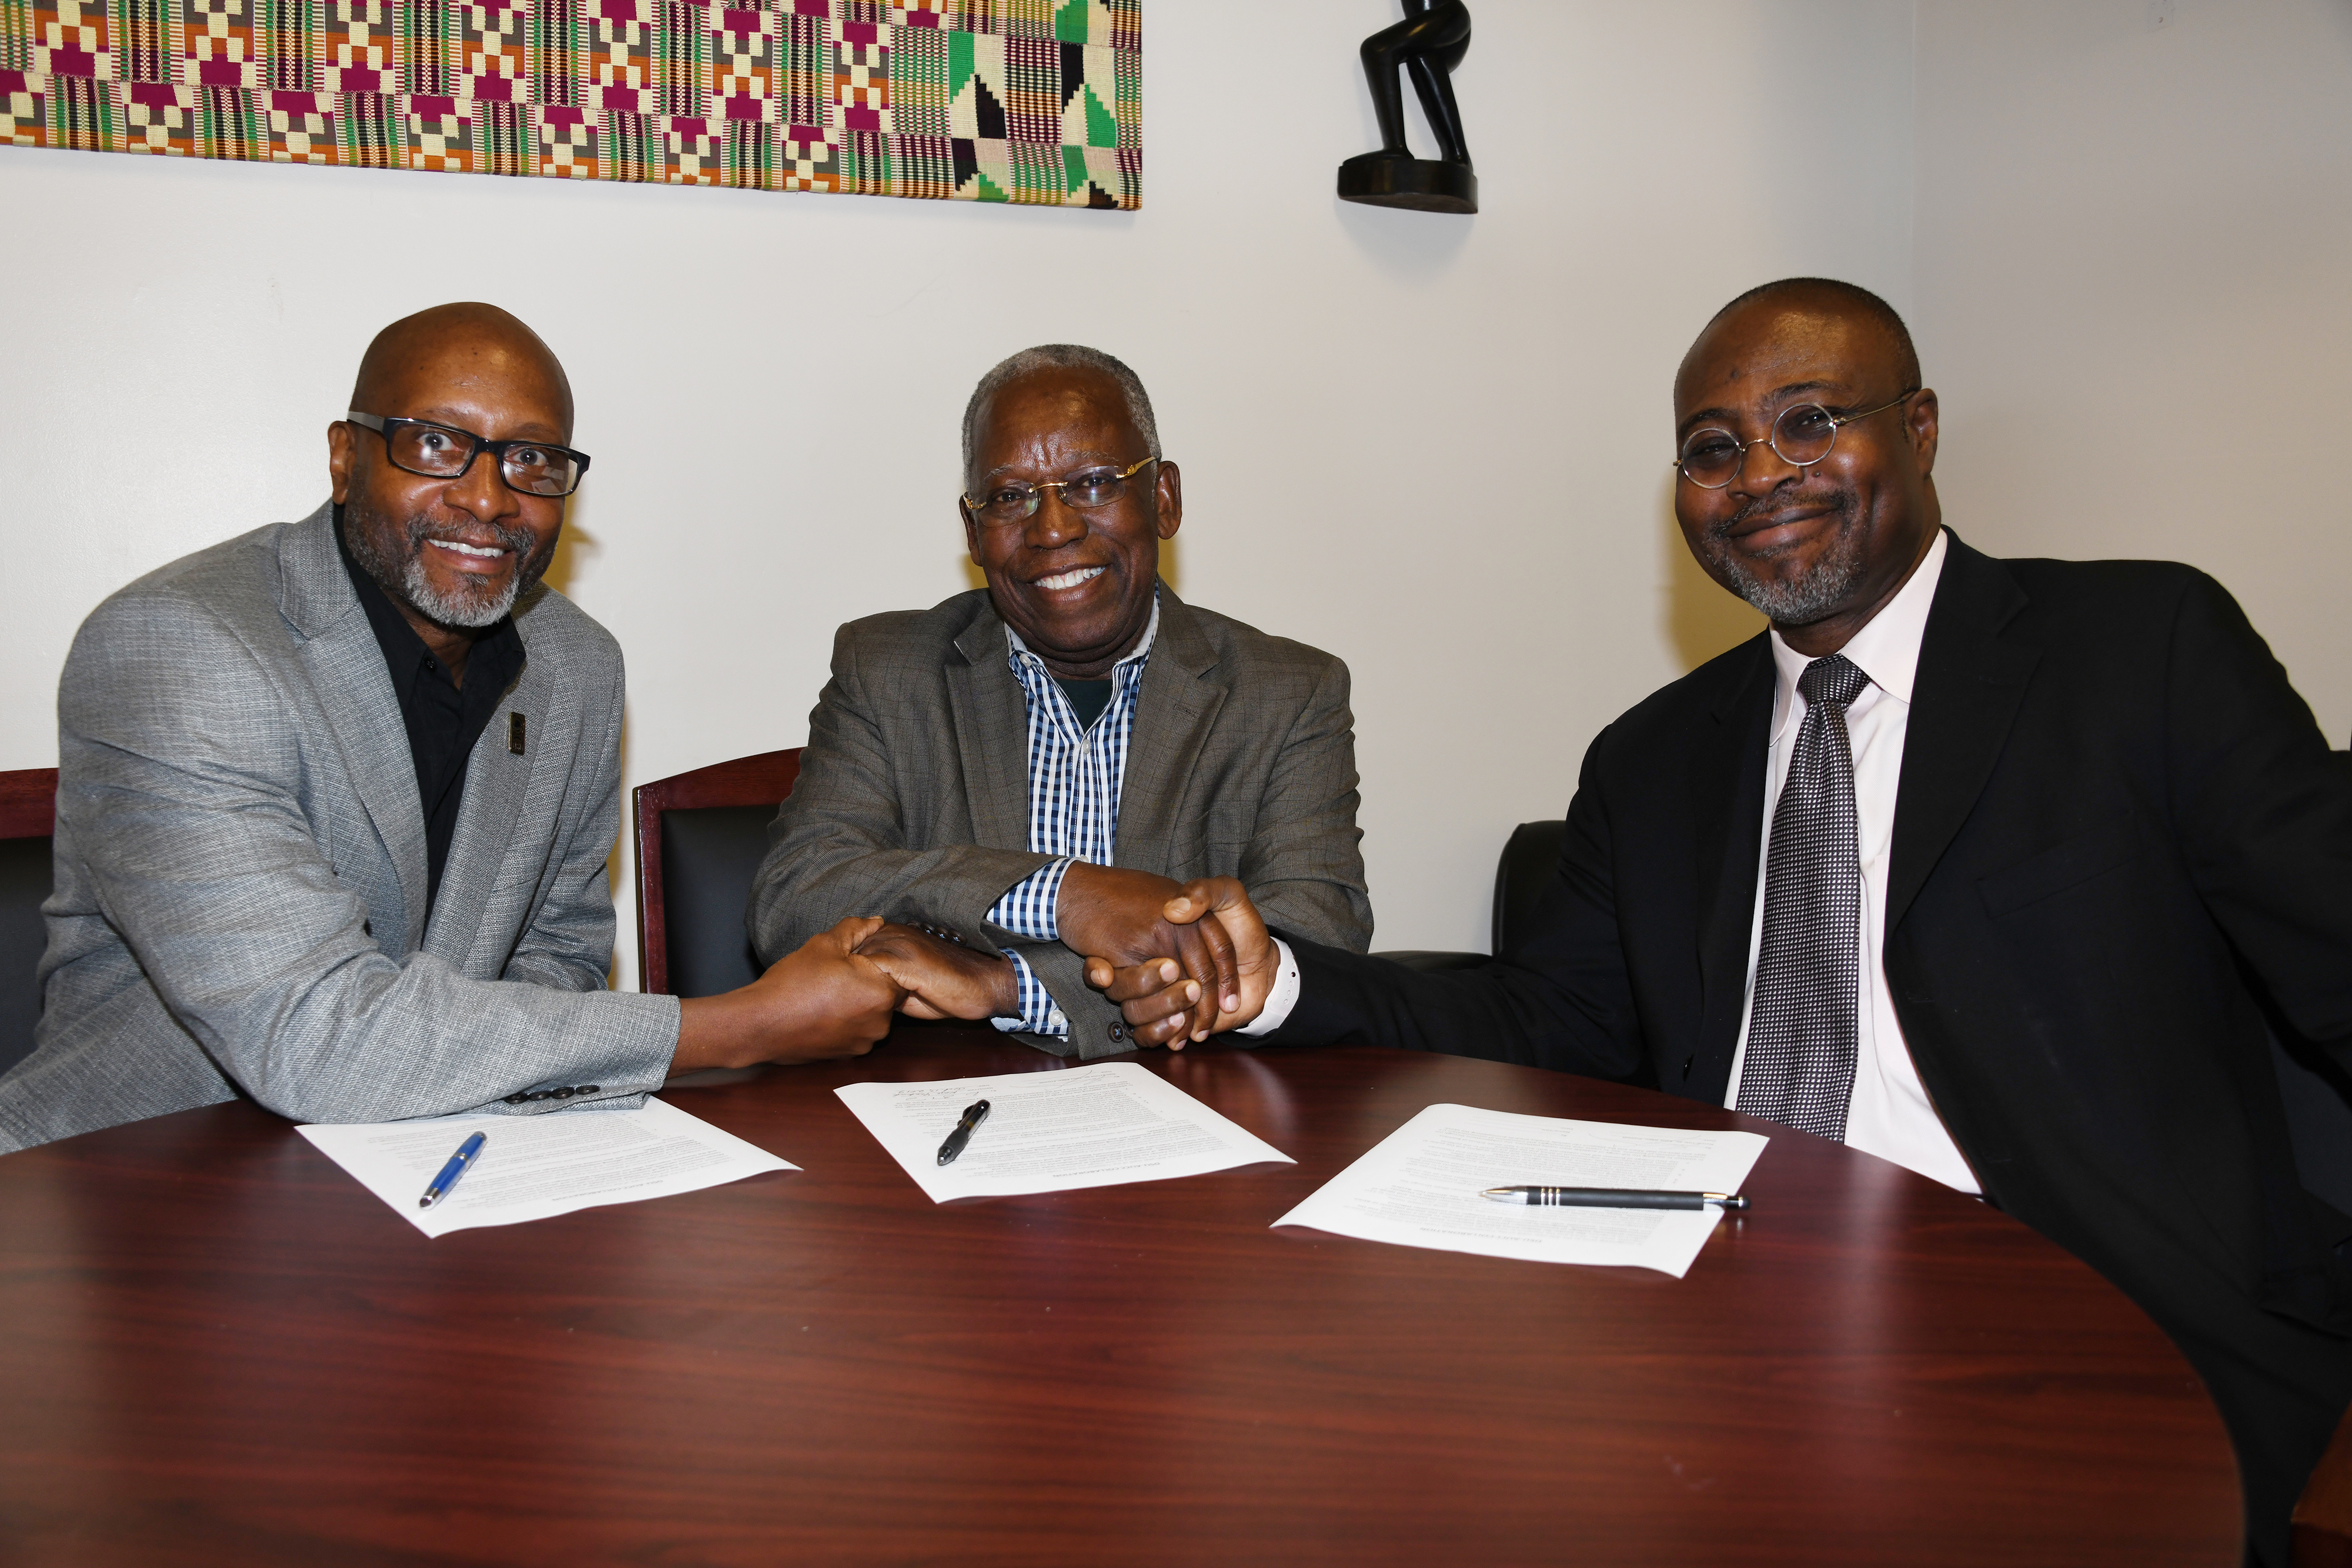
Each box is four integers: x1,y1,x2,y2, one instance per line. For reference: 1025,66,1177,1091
988,590,1160,1037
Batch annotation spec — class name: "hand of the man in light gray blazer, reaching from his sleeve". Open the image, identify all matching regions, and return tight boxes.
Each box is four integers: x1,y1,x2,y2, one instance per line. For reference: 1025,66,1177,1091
670,917,906,1076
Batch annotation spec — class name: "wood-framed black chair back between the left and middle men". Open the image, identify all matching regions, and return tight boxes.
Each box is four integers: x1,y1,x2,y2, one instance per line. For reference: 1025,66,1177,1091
630,745,800,997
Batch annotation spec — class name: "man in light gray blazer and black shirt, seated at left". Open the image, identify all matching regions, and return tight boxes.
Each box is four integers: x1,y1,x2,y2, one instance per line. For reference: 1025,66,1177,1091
0,306,903,1149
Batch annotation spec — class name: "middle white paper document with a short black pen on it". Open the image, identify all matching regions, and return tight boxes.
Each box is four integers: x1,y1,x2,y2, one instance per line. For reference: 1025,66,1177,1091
833,1062,1294,1203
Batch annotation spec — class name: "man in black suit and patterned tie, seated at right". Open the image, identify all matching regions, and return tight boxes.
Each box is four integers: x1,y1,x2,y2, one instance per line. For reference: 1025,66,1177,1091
1089,280,2352,1568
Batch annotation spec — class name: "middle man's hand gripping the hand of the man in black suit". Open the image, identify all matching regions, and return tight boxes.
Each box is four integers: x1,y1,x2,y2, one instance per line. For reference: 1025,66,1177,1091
1054,860,1247,1048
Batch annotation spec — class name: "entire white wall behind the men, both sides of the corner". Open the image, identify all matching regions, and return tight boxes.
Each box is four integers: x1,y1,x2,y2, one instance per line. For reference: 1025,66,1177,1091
18,0,2352,982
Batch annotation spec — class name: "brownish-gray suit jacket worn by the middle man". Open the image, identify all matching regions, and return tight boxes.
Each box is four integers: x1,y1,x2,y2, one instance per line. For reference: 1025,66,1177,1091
748,583,1371,1055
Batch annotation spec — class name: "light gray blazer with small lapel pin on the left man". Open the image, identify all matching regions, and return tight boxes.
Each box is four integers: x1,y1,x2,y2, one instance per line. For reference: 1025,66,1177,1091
0,508,677,1149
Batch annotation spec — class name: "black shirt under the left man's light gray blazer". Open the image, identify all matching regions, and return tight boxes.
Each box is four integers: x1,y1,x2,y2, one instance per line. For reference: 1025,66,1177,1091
334,508,522,919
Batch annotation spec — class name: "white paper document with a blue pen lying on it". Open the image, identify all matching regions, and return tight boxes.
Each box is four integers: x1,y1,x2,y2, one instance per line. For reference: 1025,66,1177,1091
294,1100,800,1236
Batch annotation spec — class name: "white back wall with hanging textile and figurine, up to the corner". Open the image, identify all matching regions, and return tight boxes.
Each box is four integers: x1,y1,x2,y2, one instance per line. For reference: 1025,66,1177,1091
0,0,1912,982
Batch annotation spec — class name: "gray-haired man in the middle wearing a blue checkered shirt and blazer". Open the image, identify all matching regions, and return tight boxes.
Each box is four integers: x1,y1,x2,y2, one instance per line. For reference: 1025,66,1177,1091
748,343,1371,1058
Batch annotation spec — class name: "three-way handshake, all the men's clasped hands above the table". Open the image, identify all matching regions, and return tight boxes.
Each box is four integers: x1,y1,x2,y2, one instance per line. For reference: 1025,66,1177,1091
670,862,1277,1076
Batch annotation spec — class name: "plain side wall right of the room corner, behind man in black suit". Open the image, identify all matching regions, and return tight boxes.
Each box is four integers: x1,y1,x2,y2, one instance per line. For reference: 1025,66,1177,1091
1912,0,2352,745
